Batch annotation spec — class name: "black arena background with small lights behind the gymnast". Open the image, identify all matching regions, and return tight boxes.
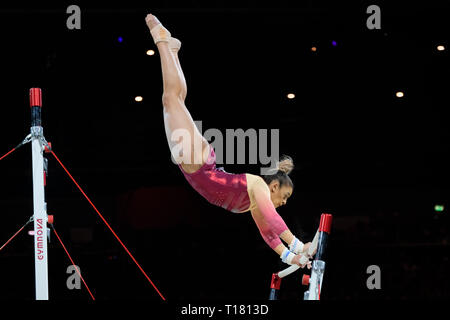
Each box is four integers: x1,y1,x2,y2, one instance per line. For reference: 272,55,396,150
0,1,450,303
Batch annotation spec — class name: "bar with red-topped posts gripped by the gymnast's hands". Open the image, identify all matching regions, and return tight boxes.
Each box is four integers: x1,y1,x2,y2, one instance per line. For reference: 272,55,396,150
269,213,333,300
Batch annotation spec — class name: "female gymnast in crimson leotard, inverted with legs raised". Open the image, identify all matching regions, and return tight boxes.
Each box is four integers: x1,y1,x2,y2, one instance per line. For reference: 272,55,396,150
145,14,311,268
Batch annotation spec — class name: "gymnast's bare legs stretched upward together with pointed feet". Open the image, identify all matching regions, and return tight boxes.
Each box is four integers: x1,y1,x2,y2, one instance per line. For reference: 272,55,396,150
146,14,209,173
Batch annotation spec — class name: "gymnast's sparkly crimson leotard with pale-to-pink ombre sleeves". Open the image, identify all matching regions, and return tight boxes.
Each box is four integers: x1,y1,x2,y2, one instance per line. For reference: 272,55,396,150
178,145,288,249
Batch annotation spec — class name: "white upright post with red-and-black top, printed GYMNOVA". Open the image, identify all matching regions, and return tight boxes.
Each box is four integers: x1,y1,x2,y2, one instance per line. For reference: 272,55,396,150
30,88,48,300
